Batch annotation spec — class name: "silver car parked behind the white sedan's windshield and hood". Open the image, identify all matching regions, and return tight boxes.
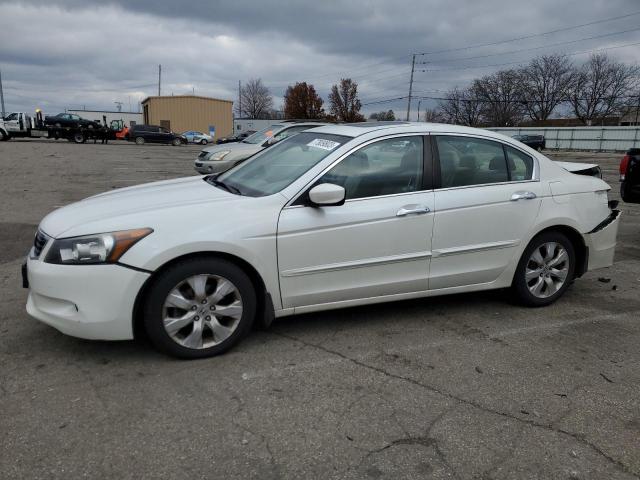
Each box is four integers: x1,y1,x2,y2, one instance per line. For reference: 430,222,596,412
194,121,324,174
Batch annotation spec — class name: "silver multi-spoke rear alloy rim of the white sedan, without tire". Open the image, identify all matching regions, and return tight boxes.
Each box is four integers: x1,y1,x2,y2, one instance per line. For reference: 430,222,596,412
525,242,570,298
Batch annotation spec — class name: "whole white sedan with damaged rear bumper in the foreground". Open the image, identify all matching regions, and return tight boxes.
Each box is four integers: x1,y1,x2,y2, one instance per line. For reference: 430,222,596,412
23,123,619,358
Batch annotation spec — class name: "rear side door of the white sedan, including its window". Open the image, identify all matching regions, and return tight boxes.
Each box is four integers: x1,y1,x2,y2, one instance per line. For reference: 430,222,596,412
429,135,544,289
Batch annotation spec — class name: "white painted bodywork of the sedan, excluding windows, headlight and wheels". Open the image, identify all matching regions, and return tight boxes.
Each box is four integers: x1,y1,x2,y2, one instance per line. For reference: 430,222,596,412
27,123,618,339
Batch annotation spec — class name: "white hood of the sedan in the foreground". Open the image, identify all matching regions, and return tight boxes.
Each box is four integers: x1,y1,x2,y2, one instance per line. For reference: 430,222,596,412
40,176,238,238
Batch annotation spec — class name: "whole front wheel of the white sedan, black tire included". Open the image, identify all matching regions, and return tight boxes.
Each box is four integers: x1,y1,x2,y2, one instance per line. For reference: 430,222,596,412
144,257,257,359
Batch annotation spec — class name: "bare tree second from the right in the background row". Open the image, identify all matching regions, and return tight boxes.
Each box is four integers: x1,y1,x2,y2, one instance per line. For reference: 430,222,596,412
520,54,576,120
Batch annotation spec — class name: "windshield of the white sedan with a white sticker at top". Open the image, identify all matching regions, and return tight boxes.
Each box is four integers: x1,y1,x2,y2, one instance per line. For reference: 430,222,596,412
216,132,351,197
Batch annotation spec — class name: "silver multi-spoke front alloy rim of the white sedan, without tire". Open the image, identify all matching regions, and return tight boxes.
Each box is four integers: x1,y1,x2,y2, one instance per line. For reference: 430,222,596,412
162,274,243,349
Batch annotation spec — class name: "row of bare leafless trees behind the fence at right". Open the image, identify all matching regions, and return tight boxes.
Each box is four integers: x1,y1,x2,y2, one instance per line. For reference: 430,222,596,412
432,53,640,127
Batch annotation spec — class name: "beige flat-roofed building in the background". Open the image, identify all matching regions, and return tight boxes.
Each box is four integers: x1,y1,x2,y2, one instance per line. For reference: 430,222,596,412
142,95,233,138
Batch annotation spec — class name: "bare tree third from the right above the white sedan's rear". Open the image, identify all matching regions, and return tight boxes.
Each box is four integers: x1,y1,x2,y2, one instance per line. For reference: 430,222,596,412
471,69,524,127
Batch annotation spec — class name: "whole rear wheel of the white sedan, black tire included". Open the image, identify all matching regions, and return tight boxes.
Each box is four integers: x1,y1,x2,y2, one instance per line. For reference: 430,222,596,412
511,231,576,307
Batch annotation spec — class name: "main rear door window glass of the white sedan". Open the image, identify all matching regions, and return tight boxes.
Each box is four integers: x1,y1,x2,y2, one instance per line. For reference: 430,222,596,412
436,135,509,188
